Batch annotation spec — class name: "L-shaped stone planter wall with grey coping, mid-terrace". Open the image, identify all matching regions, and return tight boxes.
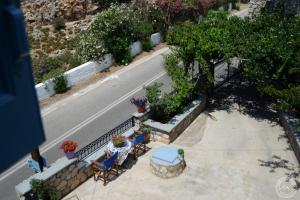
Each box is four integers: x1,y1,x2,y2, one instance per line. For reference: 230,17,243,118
144,95,206,144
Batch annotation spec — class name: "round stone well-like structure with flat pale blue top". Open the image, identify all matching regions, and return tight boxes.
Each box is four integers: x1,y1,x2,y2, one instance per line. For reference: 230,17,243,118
150,147,185,178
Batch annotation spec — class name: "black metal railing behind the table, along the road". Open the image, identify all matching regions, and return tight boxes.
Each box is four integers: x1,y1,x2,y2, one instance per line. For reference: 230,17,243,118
75,117,135,161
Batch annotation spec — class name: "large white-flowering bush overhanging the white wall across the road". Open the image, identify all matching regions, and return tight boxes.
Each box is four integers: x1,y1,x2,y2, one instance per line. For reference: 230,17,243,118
77,4,153,64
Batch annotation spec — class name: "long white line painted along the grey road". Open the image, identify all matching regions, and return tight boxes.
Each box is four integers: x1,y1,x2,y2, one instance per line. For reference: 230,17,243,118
0,71,166,181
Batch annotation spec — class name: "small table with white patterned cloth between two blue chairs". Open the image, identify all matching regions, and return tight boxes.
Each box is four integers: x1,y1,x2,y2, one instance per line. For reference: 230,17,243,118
106,140,133,165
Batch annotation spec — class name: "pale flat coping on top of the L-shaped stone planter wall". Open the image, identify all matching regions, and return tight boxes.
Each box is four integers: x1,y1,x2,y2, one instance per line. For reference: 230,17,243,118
144,95,206,133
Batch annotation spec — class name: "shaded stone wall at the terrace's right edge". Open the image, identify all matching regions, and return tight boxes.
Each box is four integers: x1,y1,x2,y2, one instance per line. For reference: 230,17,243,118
279,112,300,163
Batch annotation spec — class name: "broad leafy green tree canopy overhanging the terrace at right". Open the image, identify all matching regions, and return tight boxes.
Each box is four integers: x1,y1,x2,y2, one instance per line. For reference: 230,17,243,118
168,11,300,112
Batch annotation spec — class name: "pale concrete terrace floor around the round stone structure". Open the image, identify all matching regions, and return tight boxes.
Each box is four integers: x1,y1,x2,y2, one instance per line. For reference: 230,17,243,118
64,78,300,200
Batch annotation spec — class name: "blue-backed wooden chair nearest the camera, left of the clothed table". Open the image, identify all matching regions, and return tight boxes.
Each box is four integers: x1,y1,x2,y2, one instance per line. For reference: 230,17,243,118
92,152,119,185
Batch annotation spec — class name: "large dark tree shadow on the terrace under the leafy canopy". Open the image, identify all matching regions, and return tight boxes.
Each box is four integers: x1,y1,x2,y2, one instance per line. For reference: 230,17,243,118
208,74,278,125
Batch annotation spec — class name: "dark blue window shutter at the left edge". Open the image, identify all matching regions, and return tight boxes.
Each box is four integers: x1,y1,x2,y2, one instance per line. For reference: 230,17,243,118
0,0,45,173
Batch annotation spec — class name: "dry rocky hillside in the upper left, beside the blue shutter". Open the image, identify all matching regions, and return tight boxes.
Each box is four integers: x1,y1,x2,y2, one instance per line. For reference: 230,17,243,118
21,0,98,82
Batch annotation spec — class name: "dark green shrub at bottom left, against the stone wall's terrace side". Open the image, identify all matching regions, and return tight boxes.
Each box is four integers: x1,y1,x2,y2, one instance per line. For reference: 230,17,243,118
30,179,58,200
